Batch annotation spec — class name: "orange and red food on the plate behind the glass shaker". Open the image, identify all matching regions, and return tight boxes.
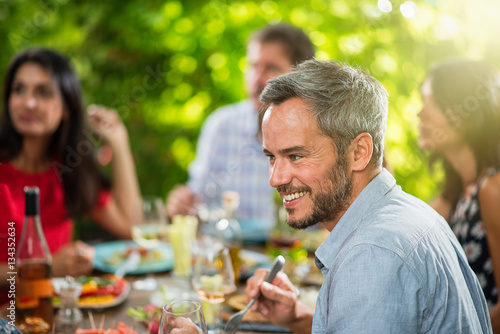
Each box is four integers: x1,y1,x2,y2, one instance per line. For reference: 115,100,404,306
53,274,129,307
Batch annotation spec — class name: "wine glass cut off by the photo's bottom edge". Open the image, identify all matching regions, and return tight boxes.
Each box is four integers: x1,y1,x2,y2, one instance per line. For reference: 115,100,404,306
158,300,208,334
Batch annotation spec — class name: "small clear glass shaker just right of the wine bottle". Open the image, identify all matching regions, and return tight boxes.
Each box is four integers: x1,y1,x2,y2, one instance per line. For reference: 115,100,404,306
55,276,83,334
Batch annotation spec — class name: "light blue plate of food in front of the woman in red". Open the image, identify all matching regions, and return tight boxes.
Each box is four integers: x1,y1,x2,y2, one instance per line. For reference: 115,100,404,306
94,241,174,275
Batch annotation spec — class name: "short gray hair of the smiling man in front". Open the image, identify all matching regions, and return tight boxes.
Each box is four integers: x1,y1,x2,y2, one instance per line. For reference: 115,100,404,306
260,59,389,166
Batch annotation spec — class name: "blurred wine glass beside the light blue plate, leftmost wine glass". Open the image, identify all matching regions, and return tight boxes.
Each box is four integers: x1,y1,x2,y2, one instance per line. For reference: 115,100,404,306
132,196,168,290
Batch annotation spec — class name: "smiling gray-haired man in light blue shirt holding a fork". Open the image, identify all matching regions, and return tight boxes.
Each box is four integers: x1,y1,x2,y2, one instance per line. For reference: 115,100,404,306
246,60,492,334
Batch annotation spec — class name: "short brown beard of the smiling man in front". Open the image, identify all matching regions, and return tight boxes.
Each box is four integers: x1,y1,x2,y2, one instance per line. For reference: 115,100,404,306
277,159,352,229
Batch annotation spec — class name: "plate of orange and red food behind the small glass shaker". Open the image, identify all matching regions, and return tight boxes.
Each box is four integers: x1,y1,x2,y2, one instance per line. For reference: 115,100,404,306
52,275,130,309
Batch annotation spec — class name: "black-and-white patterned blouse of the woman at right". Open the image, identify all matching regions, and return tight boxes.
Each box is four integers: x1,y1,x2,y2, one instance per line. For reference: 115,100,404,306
450,169,499,308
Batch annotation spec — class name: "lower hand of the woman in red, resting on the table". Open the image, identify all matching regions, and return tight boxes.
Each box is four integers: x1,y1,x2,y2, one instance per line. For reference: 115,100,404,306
52,241,95,277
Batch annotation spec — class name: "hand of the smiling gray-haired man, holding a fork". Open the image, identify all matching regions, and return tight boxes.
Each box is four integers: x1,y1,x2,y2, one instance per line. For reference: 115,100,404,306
245,269,314,333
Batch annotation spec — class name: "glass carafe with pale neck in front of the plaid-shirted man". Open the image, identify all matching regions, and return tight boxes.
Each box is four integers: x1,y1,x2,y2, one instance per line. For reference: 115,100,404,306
216,191,243,283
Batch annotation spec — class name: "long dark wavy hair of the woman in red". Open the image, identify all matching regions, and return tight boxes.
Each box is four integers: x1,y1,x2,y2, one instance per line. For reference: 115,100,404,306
0,48,110,217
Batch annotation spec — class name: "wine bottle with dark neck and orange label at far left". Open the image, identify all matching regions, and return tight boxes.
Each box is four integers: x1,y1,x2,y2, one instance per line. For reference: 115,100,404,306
16,187,54,334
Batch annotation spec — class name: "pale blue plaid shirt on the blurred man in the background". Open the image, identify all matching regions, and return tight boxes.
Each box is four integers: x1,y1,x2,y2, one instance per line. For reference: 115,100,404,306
188,100,275,229
